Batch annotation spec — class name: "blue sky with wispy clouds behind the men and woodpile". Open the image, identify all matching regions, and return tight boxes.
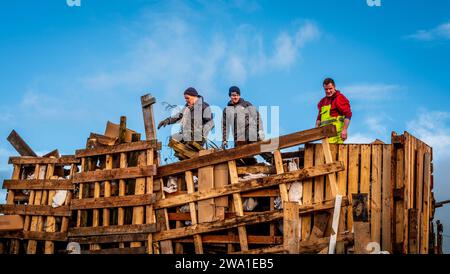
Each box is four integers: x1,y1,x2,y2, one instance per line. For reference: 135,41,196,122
0,0,450,251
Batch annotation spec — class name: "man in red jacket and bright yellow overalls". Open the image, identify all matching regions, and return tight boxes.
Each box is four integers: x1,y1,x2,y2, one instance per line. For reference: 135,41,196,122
316,78,352,144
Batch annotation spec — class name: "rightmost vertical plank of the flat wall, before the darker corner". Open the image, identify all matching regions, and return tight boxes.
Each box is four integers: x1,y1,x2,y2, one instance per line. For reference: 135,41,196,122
381,145,394,253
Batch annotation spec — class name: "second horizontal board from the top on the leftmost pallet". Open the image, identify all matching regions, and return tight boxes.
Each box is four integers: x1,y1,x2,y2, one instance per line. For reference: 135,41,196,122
3,179,75,190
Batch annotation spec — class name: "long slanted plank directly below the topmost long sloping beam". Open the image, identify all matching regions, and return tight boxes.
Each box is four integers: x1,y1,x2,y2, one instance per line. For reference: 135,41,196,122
154,162,343,209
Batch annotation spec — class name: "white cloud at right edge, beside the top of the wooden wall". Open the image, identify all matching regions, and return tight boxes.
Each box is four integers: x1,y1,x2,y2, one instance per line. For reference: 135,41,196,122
407,110,450,158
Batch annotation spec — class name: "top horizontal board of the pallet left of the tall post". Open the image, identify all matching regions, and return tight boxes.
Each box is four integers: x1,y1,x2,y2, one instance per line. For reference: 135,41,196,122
75,141,160,158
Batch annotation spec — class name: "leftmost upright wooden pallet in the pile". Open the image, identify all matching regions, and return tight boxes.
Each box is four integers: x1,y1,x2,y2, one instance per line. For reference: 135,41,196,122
0,156,79,254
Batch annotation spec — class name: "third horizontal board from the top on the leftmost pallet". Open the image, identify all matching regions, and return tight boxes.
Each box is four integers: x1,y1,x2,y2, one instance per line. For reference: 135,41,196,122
0,205,72,217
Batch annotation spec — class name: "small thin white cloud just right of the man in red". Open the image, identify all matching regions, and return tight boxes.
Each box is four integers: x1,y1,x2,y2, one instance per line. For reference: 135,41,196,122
342,84,404,101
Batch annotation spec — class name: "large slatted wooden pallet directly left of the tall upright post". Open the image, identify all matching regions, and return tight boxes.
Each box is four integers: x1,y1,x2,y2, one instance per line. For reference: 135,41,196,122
68,138,159,254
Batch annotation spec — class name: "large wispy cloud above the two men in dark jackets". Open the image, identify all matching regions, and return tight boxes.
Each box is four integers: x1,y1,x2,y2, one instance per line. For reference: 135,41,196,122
80,1,320,100
